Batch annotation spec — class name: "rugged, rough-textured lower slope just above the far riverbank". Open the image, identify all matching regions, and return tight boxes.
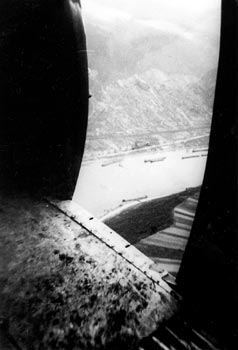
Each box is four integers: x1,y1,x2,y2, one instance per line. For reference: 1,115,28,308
87,69,214,153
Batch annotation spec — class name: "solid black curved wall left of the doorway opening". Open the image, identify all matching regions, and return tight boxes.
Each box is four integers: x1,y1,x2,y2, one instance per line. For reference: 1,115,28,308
0,0,88,194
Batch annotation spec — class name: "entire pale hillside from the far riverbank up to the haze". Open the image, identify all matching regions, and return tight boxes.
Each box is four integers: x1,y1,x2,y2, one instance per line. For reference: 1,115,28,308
81,0,219,156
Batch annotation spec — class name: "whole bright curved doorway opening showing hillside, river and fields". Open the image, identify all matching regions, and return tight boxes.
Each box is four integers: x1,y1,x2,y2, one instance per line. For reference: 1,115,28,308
73,0,221,275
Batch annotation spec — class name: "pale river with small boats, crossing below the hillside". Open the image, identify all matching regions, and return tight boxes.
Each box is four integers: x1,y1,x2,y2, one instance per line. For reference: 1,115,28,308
73,150,207,218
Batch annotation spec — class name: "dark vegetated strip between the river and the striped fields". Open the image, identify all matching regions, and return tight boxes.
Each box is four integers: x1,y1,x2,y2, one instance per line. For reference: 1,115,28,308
105,187,200,244
